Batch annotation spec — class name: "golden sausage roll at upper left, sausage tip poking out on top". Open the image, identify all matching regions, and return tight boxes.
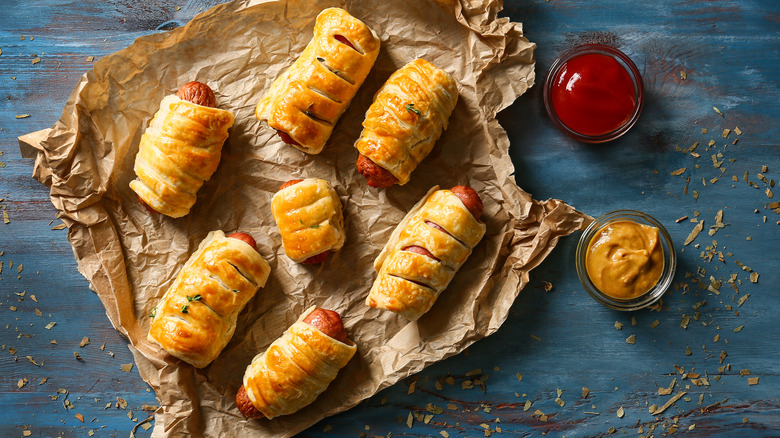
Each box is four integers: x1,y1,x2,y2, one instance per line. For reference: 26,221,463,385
130,82,234,217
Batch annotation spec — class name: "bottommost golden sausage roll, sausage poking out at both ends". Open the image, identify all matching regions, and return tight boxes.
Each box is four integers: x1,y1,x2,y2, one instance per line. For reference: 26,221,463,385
236,307,357,420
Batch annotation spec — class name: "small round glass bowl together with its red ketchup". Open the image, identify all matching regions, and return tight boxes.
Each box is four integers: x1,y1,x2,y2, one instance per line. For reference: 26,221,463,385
544,44,644,143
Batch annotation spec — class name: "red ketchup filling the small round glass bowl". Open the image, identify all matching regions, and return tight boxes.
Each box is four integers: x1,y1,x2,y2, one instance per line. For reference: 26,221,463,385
549,49,638,136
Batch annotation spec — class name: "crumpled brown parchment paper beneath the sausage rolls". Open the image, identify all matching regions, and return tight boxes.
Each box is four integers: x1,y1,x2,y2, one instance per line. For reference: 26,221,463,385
20,0,590,437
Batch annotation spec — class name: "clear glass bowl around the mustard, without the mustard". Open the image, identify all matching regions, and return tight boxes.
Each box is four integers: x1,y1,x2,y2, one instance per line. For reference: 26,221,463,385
575,210,677,311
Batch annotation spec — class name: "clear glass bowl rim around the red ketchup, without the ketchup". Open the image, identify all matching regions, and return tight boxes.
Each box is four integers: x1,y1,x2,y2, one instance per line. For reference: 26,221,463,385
543,44,645,143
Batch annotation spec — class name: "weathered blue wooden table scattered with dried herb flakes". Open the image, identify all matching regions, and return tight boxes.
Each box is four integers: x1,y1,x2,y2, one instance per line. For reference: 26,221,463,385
0,0,780,438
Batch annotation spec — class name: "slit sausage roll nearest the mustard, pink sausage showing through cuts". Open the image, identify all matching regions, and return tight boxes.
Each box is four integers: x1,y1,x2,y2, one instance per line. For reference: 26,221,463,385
366,186,485,321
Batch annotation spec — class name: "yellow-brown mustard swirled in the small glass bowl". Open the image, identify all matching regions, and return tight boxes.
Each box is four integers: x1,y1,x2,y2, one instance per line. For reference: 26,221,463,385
585,221,664,300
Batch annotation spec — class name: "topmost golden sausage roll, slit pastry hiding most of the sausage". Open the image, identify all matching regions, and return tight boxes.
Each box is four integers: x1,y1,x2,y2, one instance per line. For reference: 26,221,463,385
255,8,379,154
